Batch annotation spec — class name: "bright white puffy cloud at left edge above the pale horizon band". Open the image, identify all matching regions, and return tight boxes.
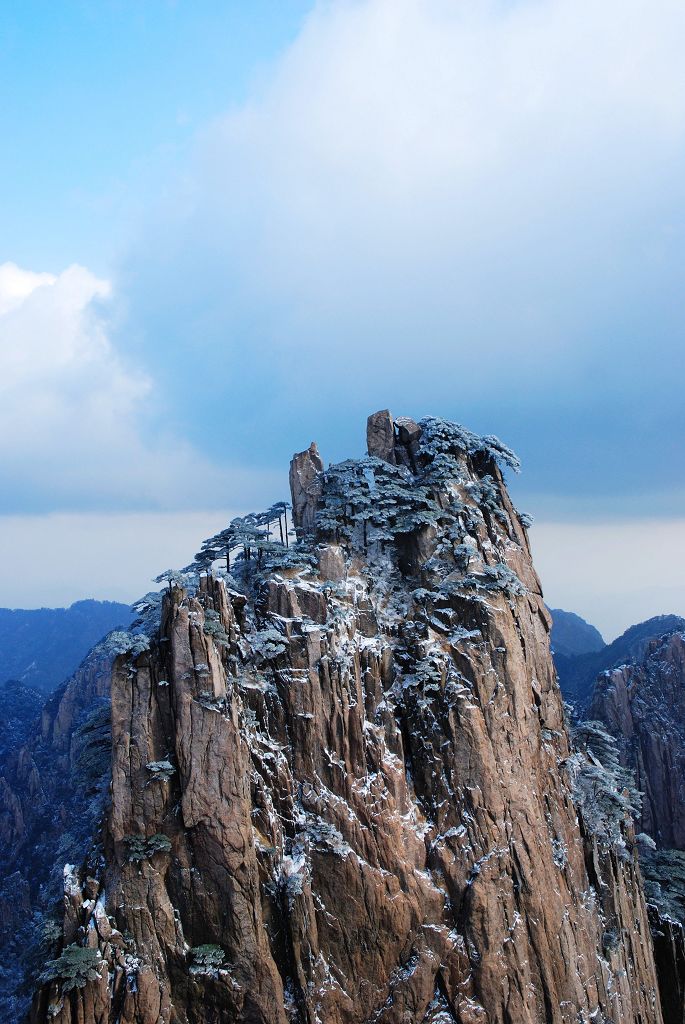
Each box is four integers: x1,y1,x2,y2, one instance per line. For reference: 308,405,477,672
0,263,280,510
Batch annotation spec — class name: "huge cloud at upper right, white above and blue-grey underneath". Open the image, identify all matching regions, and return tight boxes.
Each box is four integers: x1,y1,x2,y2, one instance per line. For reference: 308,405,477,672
120,0,685,514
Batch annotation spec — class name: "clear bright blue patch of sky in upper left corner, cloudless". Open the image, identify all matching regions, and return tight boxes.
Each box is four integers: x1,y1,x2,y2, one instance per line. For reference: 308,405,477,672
0,0,310,274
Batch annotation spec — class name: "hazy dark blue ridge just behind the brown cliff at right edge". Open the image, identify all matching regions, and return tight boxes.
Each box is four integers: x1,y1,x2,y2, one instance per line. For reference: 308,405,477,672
554,615,685,714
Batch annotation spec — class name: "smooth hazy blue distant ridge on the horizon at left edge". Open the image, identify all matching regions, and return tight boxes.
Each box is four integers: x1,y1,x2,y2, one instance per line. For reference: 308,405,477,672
0,599,133,693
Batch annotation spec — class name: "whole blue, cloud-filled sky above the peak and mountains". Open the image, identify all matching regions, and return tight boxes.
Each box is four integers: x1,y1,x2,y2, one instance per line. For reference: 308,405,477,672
0,0,685,639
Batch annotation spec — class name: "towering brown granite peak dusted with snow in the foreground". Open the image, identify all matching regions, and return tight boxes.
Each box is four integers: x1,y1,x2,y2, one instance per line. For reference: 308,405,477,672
33,414,662,1024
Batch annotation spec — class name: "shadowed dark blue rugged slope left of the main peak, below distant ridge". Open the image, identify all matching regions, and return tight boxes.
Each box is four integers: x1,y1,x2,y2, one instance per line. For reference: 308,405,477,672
0,634,133,1022
